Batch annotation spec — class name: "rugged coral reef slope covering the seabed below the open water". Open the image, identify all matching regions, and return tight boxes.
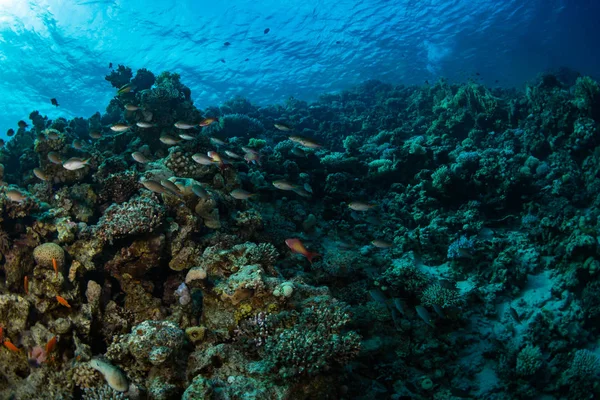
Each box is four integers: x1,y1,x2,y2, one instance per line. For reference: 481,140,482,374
0,65,600,400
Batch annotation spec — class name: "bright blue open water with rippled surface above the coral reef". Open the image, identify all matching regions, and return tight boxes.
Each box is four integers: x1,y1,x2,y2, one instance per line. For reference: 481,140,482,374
0,0,600,138
